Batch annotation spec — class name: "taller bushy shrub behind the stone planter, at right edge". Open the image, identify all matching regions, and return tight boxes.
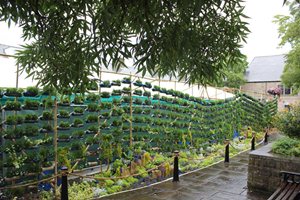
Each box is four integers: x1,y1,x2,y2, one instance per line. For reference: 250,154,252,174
273,104,300,138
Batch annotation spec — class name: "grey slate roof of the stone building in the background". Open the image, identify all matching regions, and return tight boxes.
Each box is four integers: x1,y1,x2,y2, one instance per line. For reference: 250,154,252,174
245,54,285,82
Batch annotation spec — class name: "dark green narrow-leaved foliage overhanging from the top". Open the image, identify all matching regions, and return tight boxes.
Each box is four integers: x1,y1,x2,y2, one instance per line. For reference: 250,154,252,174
0,0,249,91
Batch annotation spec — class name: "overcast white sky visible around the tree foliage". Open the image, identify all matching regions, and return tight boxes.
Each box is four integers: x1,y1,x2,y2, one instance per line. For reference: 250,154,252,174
0,0,290,87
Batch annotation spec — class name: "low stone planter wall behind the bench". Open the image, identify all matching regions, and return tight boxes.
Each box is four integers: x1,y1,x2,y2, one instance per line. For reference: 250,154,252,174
248,144,300,193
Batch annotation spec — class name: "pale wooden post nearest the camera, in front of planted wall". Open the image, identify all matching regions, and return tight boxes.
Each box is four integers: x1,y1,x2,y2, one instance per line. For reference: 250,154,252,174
53,96,58,199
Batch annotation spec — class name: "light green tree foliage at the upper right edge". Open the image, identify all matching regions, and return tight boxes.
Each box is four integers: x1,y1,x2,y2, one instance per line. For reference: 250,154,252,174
275,1,300,90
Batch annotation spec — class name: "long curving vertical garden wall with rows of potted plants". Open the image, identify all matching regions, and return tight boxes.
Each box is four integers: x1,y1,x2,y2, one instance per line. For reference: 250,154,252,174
1,78,277,188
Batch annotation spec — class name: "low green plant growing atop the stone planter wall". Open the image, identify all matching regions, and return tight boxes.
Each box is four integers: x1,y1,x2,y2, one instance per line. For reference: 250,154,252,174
272,137,300,157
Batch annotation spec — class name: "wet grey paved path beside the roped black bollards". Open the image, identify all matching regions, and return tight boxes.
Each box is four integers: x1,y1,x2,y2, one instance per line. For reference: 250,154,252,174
101,152,268,200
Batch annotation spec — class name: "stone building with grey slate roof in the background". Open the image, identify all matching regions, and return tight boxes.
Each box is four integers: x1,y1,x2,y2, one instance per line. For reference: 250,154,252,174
241,55,300,109
